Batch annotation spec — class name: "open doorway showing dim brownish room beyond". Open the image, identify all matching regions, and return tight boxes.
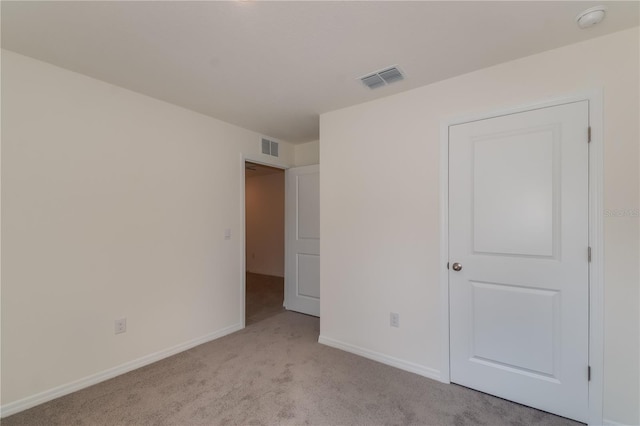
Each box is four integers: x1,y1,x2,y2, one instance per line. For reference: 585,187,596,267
244,161,285,325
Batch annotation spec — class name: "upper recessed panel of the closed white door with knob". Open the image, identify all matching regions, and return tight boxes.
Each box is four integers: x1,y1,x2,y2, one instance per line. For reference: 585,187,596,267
472,125,560,257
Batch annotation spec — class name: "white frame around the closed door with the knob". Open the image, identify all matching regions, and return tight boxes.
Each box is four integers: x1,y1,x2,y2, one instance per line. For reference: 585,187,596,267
440,89,604,425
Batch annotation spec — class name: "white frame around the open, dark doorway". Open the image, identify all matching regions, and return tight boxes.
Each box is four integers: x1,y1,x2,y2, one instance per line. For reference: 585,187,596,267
240,153,290,328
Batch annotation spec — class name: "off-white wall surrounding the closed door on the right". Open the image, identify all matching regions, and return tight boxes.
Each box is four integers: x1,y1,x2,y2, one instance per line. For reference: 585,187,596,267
320,28,640,424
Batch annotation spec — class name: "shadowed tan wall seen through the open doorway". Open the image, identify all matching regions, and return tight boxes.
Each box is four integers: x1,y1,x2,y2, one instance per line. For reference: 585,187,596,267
245,172,284,277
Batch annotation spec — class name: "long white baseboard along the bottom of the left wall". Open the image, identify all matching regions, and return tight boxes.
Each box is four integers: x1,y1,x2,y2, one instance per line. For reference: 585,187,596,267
0,324,242,418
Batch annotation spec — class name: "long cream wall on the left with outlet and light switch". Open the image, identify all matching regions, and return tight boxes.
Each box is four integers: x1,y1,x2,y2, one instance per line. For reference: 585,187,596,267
2,51,293,415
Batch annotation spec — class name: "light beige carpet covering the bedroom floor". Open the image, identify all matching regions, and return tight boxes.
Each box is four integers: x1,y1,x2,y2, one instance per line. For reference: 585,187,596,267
2,312,577,426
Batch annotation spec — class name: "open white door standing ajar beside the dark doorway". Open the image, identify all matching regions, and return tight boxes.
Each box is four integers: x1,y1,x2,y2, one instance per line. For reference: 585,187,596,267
284,165,320,316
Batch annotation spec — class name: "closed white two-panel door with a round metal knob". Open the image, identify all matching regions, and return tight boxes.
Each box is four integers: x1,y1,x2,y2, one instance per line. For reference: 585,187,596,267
449,101,589,422
